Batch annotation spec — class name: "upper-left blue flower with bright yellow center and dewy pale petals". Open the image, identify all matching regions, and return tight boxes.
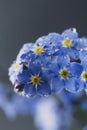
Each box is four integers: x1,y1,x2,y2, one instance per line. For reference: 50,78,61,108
17,33,61,66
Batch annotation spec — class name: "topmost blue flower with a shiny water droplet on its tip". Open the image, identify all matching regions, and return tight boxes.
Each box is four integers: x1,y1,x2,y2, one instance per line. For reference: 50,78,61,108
58,28,79,59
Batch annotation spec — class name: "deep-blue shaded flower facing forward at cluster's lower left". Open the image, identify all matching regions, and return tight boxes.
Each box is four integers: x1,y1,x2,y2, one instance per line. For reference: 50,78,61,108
17,63,51,97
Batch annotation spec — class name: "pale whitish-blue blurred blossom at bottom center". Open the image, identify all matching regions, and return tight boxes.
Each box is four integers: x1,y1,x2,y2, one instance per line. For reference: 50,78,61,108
35,97,71,130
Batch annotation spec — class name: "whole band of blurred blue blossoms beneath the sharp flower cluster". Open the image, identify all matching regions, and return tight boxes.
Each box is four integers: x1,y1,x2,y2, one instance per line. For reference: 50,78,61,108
0,84,87,130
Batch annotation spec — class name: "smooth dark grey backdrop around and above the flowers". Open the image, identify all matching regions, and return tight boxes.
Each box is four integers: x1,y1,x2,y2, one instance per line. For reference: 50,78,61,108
0,0,87,130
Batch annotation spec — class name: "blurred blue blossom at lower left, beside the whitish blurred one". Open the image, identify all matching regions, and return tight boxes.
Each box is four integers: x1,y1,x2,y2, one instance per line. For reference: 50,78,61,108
0,83,39,120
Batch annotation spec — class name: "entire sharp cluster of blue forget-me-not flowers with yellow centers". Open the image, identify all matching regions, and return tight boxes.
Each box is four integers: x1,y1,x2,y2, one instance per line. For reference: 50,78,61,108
9,28,87,97
